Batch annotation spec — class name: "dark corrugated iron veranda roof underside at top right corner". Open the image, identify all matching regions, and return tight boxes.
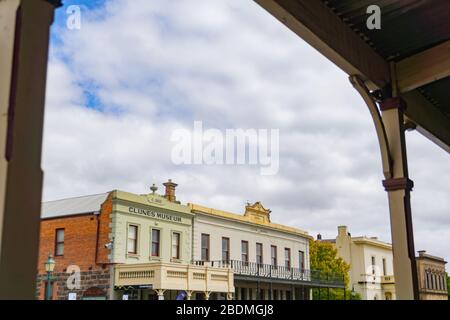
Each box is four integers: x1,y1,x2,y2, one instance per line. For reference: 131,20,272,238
322,0,450,61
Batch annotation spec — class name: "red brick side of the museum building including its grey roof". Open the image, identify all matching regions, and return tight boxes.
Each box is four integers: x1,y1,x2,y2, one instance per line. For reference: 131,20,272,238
36,193,112,300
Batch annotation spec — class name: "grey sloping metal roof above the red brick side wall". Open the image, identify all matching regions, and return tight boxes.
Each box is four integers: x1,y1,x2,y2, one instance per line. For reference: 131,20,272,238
41,193,109,219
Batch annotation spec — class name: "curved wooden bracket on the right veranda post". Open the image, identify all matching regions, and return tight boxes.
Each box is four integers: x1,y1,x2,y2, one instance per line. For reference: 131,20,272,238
349,75,392,179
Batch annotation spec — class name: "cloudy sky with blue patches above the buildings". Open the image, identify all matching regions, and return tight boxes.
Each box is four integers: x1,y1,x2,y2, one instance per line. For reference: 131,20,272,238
43,0,450,260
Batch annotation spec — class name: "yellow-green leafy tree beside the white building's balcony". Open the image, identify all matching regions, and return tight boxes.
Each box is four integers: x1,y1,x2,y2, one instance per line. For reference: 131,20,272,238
309,240,361,300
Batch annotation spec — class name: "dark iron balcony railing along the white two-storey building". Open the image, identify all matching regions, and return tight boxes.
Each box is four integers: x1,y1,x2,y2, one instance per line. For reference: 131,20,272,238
194,260,344,287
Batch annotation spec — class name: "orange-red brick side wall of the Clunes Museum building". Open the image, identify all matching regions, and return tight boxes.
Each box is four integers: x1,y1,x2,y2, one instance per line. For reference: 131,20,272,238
37,194,112,299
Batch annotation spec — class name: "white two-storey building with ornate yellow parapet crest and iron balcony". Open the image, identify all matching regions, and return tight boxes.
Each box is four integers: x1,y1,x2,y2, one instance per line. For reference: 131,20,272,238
189,202,344,300
